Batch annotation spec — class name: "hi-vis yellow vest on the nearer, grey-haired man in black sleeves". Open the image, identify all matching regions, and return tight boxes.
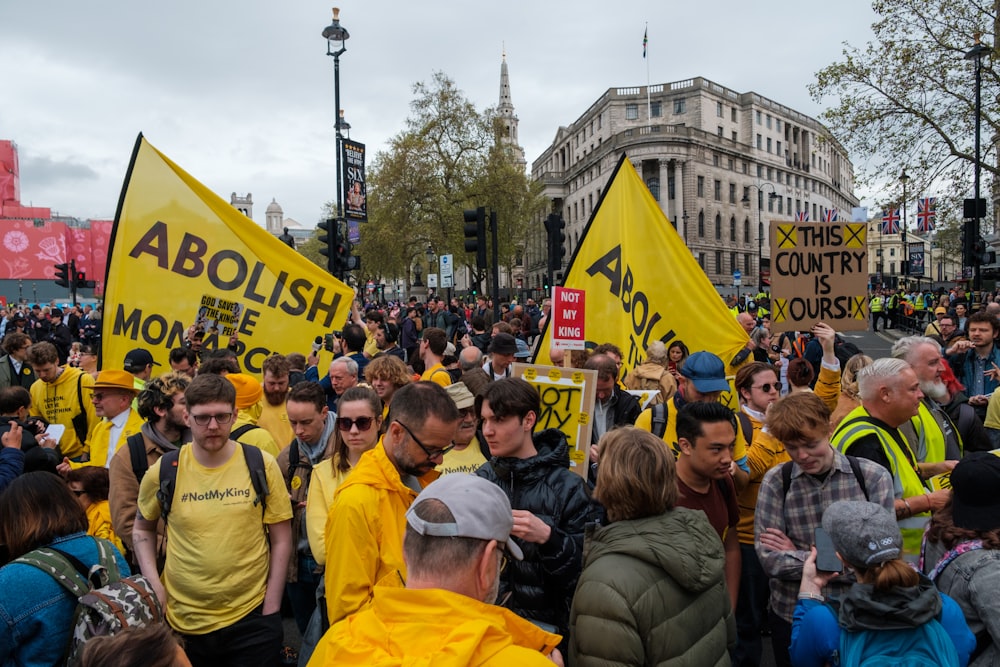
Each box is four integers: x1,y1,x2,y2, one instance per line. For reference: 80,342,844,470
830,405,928,561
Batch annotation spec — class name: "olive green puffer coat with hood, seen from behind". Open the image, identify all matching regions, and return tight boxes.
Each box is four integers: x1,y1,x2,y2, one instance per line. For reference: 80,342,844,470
570,508,736,667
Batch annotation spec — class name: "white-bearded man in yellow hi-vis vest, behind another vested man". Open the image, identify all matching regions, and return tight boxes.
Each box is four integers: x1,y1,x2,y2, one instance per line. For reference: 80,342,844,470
891,336,962,472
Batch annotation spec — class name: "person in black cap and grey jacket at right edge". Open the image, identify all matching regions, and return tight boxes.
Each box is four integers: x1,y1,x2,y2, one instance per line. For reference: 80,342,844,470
921,452,1000,667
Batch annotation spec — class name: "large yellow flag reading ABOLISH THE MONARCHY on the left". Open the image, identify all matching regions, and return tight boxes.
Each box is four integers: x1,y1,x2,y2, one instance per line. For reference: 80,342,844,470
102,135,354,374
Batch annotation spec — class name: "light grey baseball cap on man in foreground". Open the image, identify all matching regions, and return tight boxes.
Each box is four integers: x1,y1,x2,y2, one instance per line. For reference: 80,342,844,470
406,473,524,560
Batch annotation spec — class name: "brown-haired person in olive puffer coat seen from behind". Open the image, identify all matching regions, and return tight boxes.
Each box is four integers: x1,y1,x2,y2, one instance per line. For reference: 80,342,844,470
567,426,733,667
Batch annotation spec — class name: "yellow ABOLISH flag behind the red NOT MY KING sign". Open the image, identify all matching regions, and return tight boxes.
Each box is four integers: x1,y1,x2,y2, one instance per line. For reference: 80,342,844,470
535,155,747,407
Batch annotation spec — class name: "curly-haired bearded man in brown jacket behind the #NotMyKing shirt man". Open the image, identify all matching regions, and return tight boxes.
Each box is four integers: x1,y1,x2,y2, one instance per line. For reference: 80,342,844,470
108,372,191,565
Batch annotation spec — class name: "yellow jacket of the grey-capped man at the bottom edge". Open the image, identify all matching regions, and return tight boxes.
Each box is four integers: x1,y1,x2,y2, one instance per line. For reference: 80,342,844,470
309,586,560,667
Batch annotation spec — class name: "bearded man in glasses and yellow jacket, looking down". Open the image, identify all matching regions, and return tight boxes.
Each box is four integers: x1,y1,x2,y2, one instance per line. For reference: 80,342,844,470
326,382,460,625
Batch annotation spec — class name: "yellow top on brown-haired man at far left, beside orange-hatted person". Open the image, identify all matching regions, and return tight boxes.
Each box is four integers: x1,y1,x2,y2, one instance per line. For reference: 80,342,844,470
30,366,97,459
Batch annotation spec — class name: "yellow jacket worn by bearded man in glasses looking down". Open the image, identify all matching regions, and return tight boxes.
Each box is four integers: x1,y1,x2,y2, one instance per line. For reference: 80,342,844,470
324,442,438,625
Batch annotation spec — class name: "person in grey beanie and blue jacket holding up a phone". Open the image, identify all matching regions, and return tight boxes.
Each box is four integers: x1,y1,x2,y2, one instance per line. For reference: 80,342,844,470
789,500,975,667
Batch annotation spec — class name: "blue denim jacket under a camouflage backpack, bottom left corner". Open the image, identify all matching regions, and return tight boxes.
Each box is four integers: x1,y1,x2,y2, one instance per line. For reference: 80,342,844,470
0,533,131,667
